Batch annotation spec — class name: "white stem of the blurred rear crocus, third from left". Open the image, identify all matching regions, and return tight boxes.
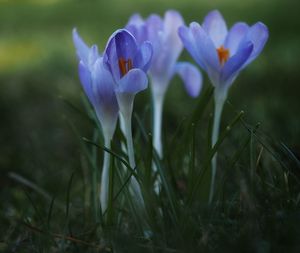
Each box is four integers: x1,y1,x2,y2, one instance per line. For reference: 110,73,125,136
153,94,164,158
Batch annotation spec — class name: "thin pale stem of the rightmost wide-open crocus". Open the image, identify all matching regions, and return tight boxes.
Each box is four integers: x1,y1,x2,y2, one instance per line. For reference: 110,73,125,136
209,89,227,203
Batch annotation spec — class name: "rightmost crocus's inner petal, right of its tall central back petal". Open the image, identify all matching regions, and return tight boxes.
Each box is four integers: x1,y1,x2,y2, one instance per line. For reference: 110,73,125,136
224,22,249,56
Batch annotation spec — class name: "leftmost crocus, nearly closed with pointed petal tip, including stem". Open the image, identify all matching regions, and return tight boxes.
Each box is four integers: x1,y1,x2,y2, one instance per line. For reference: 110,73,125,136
73,29,119,215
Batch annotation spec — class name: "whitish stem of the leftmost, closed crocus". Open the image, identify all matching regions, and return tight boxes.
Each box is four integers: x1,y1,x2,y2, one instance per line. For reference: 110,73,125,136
100,137,111,214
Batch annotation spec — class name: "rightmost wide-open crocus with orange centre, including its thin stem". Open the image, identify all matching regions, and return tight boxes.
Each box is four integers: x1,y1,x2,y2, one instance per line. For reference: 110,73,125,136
179,10,268,202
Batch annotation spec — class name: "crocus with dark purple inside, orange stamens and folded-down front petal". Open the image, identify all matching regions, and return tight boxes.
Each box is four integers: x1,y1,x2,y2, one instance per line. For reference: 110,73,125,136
104,29,152,206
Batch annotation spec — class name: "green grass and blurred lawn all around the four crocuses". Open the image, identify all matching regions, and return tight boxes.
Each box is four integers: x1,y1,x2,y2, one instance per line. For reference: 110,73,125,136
0,0,300,252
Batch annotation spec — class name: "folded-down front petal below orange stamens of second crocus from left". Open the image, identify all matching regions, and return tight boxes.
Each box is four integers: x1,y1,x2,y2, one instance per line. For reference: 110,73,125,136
115,69,148,94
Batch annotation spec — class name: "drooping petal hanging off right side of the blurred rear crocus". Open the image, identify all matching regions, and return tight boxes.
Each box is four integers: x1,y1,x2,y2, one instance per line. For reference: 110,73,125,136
175,62,202,97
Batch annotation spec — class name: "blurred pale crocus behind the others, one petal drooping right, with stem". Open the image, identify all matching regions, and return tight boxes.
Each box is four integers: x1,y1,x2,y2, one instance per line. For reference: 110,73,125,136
126,10,202,157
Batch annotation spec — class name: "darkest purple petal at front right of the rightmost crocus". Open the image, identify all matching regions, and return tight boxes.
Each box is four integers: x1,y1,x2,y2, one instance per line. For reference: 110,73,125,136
220,42,253,85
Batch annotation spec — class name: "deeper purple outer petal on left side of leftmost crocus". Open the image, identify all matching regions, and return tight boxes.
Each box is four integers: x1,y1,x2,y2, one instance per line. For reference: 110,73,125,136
78,61,95,104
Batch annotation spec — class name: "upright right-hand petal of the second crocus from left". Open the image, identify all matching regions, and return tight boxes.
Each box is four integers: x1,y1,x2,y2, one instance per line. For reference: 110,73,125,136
133,41,153,72
